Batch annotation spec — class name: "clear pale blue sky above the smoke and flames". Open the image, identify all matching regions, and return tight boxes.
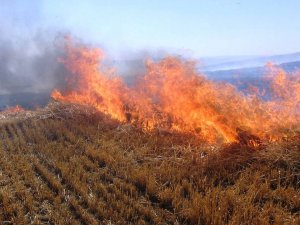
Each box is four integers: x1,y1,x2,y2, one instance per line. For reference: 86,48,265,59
0,0,300,57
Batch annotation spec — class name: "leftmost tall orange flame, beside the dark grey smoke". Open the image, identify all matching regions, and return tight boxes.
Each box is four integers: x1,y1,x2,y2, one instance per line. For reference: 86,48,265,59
52,39,127,121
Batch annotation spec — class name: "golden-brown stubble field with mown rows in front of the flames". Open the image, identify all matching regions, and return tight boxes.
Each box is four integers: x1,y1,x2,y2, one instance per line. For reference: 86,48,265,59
0,104,300,224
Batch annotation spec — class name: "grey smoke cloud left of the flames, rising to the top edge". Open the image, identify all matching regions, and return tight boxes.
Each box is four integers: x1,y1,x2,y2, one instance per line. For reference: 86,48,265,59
0,0,68,109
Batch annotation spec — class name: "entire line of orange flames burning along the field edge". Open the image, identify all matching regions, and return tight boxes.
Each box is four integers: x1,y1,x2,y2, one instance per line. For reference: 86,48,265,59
52,40,300,143
